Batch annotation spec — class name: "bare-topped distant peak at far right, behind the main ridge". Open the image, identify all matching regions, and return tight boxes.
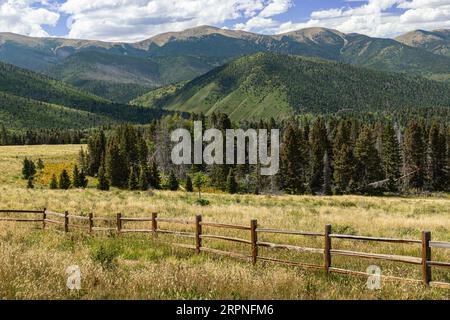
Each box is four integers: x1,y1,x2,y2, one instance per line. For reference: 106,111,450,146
396,29,450,57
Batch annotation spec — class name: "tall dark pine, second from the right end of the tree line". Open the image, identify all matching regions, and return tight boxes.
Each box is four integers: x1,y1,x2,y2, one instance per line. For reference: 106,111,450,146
404,121,426,189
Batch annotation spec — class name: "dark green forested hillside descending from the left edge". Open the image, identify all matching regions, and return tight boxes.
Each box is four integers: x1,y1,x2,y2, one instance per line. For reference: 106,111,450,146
0,63,172,128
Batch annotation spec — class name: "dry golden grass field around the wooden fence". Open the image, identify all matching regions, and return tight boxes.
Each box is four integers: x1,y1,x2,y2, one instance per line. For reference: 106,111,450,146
0,146,450,299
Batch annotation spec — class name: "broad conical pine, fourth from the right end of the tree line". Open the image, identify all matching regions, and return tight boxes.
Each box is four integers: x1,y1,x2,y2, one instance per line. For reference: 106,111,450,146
354,127,382,188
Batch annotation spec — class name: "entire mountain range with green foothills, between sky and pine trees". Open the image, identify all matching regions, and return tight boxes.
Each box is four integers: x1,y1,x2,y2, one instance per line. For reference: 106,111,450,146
0,26,450,128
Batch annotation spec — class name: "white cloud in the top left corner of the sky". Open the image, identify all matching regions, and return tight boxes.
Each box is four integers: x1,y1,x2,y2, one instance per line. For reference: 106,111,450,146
0,0,59,37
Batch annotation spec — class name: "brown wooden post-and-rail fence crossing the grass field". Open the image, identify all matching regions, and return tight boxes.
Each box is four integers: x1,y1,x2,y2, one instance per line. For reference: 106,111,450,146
0,209,450,289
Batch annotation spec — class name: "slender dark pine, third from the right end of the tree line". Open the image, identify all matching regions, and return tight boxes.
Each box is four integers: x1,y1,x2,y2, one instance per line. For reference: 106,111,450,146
381,123,402,192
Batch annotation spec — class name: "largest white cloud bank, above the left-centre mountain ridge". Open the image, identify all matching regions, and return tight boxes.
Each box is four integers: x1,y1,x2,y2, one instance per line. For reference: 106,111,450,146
60,0,274,41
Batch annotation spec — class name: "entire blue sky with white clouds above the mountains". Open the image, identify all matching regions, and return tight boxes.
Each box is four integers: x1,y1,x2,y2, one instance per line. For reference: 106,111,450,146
0,0,450,42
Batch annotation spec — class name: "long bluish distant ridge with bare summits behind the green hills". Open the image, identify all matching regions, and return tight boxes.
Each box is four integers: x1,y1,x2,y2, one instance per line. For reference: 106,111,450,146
0,26,450,102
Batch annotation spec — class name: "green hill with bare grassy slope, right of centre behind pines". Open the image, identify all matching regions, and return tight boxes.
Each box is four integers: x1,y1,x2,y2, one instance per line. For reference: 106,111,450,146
138,53,450,120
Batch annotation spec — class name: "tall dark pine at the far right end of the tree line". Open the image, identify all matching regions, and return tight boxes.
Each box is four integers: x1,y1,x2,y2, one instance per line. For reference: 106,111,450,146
428,122,450,191
